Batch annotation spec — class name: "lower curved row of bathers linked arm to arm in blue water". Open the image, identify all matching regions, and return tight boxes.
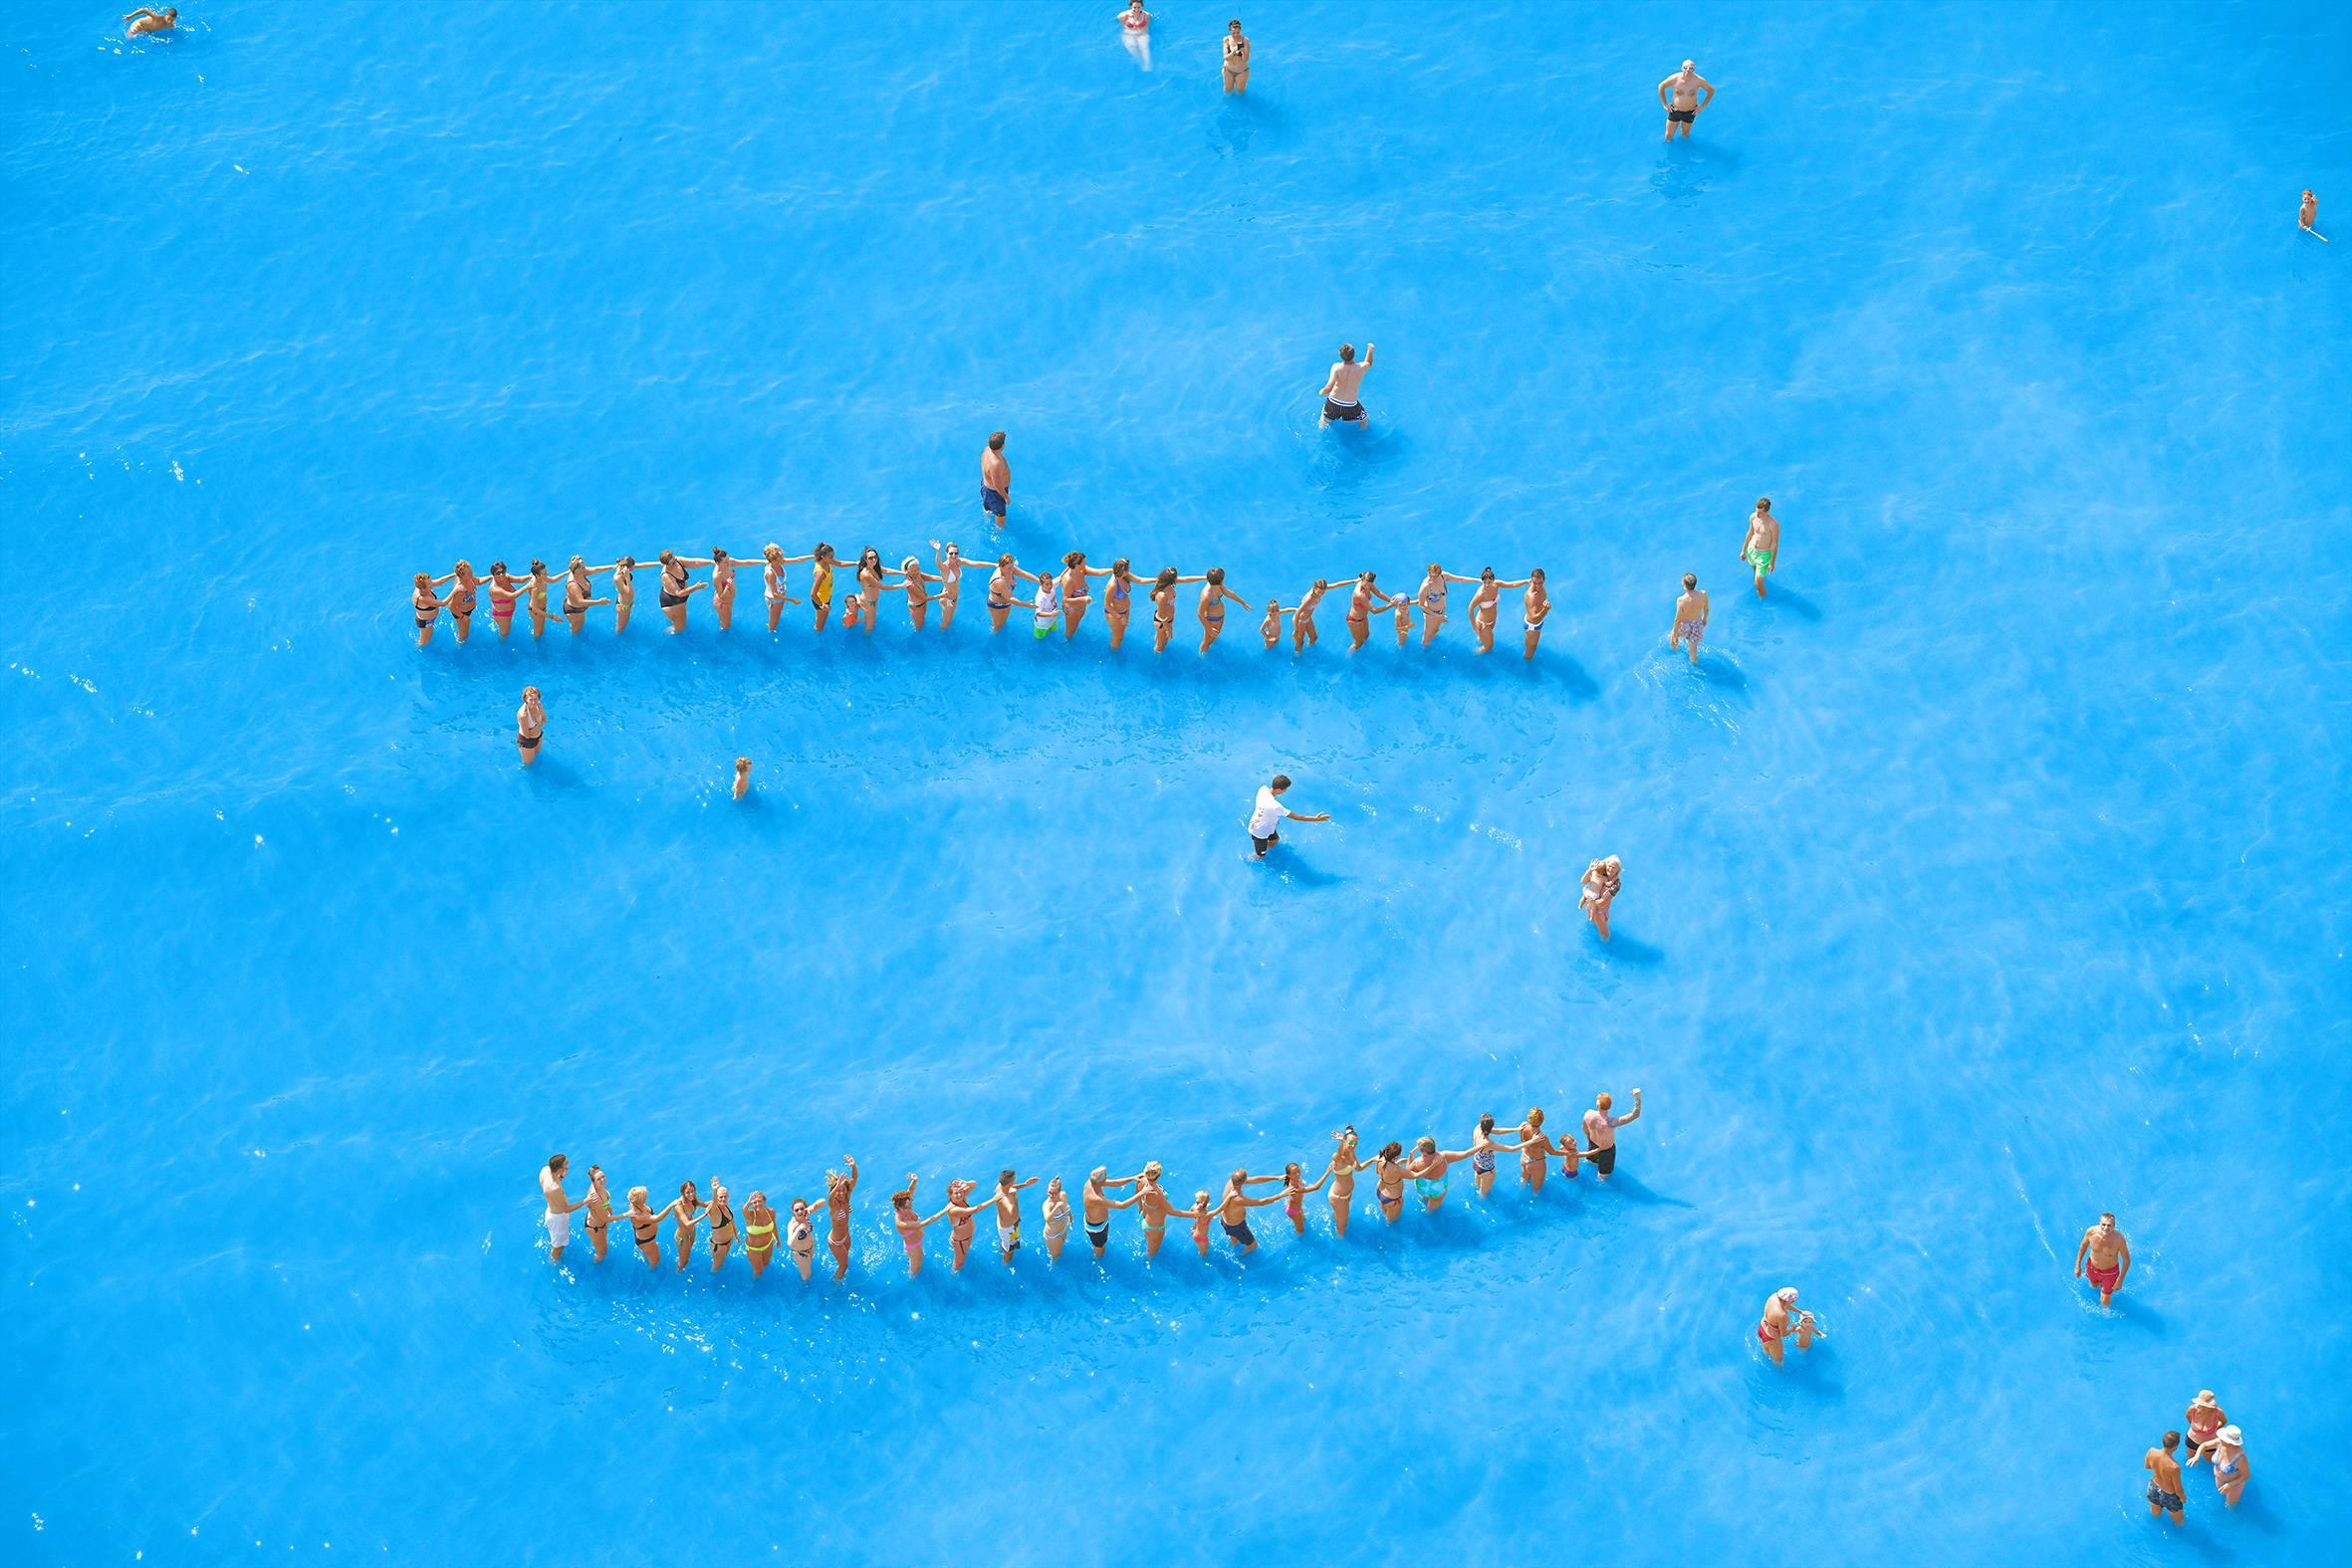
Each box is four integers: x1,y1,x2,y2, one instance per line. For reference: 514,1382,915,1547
539,1088,1642,1279
